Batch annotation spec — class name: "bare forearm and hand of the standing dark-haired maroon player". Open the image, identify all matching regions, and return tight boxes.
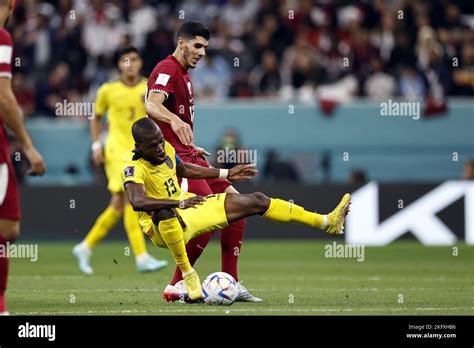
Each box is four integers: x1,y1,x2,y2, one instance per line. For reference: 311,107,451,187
146,92,194,145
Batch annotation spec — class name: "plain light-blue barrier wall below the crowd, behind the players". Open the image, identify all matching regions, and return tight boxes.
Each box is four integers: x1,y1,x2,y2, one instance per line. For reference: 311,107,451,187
27,99,474,184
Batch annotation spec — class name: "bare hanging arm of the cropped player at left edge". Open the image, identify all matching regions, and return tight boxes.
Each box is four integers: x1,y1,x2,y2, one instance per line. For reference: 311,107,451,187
0,77,46,175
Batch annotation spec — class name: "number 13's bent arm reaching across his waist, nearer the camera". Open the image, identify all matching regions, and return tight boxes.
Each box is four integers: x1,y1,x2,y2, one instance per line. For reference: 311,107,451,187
125,181,206,212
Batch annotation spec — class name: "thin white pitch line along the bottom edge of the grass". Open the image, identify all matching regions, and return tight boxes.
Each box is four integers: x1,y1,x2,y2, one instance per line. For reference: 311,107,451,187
12,307,474,315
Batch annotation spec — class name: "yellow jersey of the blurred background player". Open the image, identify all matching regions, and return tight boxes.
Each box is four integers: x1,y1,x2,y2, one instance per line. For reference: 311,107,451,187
95,78,147,161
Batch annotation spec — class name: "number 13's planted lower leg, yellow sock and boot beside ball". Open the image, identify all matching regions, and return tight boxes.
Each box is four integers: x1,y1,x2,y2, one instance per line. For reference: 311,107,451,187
152,209,202,301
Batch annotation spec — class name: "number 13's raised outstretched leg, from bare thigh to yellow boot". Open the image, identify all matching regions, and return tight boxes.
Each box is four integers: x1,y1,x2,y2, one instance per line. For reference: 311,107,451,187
225,192,351,234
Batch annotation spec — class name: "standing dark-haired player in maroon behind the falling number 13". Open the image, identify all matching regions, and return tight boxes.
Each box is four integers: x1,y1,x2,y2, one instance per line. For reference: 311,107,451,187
146,22,262,302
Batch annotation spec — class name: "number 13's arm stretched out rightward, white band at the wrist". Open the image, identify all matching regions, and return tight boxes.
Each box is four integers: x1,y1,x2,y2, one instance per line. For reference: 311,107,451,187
176,161,257,180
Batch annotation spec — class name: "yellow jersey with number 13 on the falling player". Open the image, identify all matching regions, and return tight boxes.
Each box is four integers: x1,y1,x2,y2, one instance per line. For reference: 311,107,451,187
122,141,192,233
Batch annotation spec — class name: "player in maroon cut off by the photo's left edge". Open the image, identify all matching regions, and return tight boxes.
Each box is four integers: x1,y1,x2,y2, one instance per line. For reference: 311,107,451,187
0,0,46,315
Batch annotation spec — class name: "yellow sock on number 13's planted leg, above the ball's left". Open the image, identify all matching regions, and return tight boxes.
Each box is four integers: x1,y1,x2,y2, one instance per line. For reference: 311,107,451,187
158,218,193,273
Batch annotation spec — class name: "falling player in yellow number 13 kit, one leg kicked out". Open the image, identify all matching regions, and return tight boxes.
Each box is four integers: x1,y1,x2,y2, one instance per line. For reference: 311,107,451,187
123,118,351,301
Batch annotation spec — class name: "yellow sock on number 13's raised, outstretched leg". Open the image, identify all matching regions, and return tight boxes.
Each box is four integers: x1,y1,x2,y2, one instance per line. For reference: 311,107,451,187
263,198,327,228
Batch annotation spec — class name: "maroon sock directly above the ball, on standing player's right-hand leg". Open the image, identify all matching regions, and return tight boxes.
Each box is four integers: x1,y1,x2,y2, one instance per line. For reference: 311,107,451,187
221,219,247,281
